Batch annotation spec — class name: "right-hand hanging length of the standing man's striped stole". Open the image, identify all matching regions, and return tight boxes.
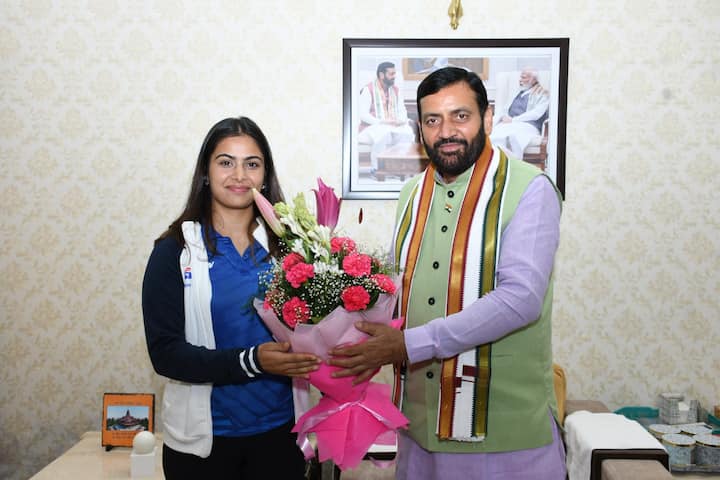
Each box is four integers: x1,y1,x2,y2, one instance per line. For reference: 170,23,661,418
438,144,507,441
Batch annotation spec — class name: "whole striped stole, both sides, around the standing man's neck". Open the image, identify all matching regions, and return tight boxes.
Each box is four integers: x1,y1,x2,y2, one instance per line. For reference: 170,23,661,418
393,140,508,441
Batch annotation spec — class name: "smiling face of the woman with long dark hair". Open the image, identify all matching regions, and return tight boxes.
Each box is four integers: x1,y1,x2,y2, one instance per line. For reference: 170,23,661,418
208,135,265,214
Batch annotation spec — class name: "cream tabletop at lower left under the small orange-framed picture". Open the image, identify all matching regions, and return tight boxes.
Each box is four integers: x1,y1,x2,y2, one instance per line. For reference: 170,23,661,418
31,432,165,480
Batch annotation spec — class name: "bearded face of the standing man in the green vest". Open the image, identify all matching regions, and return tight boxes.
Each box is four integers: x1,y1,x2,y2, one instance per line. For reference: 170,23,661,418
420,82,485,181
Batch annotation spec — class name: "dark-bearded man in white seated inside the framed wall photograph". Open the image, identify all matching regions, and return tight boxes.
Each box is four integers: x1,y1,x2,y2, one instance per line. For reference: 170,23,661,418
358,62,415,171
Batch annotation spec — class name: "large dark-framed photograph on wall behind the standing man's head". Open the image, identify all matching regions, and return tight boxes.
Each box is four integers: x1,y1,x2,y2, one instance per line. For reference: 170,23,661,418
342,38,569,199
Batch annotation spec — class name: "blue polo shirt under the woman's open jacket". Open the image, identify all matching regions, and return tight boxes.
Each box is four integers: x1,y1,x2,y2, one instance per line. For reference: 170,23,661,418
210,232,293,437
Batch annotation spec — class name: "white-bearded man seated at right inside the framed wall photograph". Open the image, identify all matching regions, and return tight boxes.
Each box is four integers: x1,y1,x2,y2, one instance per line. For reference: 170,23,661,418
490,68,550,158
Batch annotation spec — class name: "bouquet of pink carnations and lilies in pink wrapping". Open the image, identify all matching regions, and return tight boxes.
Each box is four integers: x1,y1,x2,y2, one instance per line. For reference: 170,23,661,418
253,179,408,469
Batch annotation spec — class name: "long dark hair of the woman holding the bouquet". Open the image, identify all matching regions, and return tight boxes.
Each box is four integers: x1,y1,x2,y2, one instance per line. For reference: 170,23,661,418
155,117,284,255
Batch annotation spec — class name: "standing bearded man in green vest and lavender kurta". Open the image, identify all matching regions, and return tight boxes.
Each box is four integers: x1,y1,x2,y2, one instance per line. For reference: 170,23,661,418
330,67,565,480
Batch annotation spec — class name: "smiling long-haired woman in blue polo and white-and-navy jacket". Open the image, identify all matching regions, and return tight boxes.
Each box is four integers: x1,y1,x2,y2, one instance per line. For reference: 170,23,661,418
142,117,319,480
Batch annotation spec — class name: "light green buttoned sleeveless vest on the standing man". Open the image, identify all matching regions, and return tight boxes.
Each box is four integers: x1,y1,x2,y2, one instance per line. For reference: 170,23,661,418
398,159,557,453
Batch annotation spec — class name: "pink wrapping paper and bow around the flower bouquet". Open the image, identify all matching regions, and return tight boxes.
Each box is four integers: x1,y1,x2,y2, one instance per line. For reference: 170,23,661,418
255,295,408,470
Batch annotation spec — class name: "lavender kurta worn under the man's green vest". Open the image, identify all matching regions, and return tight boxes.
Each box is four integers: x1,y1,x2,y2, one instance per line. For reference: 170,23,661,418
396,176,565,480
